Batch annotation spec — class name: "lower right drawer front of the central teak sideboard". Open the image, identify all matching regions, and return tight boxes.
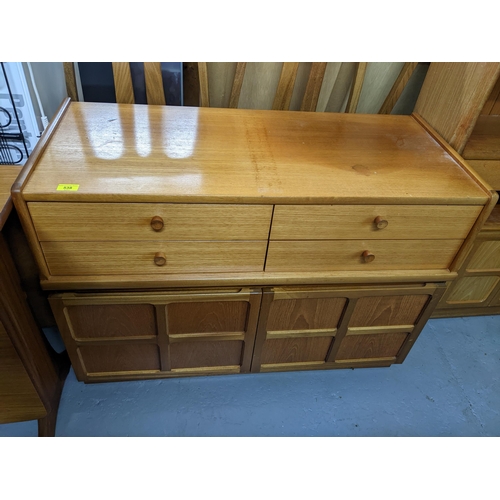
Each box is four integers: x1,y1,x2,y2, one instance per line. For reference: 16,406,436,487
266,240,463,272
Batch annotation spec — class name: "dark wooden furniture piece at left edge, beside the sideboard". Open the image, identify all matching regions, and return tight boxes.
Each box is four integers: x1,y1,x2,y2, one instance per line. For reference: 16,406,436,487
0,166,69,436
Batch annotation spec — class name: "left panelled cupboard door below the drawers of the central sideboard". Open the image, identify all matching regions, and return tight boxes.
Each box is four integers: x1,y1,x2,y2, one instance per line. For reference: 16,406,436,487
50,289,261,382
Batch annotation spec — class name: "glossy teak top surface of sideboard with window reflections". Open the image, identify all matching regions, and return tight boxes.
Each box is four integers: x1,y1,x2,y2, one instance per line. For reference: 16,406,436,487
23,102,488,205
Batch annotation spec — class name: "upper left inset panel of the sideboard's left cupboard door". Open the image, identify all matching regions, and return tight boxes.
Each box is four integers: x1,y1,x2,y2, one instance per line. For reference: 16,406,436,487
67,304,157,339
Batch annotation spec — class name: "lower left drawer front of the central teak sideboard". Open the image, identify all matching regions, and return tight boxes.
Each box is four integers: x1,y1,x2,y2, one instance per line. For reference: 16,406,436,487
41,241,267,276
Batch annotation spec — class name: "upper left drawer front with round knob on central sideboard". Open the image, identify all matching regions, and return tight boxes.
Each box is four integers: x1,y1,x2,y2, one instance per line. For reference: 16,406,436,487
28,202,272,241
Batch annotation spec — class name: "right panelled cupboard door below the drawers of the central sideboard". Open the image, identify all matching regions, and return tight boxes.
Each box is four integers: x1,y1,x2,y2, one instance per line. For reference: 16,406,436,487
252,283,445,372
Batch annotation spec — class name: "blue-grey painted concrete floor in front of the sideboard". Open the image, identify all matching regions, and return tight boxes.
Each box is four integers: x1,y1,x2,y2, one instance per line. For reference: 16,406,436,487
0,316,500,437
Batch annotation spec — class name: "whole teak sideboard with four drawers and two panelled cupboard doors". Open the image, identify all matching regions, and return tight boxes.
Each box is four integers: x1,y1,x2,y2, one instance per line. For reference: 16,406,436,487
13,100,498,382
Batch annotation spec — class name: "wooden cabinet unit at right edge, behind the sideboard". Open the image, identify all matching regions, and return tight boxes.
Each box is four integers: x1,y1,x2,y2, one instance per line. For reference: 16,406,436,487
416,63,500,317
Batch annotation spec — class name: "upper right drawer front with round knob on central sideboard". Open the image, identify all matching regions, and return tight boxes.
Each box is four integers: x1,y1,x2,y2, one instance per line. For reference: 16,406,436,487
271,205,483,240
